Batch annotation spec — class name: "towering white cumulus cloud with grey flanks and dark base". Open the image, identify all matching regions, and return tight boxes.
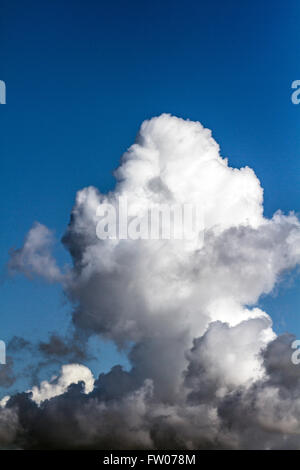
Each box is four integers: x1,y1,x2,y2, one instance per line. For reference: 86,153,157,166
0,114,300,449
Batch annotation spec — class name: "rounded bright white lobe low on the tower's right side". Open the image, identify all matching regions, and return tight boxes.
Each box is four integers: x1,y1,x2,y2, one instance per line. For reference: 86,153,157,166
185,317,274,403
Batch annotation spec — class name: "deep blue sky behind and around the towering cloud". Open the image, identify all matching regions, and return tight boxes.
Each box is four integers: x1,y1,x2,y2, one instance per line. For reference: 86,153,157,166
0,0,300,392
